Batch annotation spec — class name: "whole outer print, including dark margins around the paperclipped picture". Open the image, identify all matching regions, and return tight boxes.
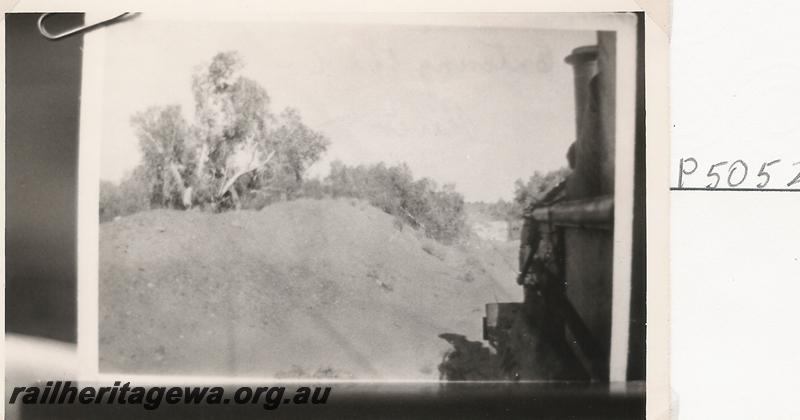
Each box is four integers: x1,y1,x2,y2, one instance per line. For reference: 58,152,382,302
6,7,663,418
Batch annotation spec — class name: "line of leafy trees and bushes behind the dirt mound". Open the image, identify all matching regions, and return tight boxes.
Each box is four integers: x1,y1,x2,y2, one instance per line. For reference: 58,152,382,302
100,51,569,242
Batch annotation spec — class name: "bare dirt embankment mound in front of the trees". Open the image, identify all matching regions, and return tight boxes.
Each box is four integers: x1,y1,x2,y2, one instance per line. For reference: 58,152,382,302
100,200,521,379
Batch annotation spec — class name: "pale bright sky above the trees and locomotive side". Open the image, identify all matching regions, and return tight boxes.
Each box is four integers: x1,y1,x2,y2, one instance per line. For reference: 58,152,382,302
101,19,596,201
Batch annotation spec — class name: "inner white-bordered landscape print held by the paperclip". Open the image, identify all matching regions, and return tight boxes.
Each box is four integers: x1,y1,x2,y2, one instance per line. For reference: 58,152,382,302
84,14,643,381
